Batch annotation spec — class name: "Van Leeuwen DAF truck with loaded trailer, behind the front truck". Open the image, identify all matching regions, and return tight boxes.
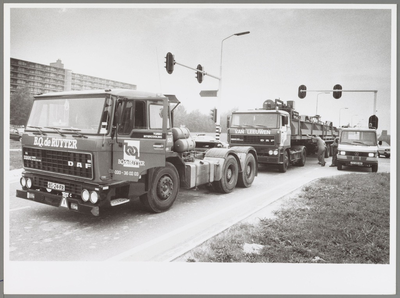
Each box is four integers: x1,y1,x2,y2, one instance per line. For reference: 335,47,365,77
228,99,338,172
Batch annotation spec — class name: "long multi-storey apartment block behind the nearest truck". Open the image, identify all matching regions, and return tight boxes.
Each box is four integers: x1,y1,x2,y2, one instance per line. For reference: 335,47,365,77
10,58,137,94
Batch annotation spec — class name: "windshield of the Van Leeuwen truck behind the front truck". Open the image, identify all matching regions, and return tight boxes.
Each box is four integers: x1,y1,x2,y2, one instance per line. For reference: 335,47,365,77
231,113,279,128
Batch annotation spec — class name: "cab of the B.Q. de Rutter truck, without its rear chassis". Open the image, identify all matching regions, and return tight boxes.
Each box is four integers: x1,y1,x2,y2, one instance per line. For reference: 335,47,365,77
17,89,173,215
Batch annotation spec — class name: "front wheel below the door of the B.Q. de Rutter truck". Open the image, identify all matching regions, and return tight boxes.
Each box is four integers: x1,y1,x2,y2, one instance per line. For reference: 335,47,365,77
140,162,179,213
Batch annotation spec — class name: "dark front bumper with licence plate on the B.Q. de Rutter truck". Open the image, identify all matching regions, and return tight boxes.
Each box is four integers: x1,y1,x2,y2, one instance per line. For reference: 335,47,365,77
17,189,100,216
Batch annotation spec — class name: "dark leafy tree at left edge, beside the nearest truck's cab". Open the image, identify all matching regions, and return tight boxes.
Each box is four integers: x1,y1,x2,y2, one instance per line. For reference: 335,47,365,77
10,87,33,125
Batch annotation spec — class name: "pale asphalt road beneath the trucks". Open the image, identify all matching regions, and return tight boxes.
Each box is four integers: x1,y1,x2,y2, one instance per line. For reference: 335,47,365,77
5,156,390,262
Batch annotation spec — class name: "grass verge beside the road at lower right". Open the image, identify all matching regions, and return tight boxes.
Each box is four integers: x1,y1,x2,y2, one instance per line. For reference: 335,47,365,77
179,173,390,264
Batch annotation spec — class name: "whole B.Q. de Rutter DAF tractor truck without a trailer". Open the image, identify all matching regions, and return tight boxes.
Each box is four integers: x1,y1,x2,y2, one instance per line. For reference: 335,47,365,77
16,89,258,215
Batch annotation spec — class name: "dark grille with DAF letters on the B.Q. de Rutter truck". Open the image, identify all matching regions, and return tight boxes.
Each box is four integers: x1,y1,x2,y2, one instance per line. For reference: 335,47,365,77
22,148,93,179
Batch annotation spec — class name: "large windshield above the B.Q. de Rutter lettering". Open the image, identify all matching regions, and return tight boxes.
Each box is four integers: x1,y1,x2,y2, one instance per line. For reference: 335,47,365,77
27,98,109,134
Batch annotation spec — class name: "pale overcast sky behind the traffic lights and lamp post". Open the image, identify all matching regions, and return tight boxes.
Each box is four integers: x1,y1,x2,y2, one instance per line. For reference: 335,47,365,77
9,5,393,132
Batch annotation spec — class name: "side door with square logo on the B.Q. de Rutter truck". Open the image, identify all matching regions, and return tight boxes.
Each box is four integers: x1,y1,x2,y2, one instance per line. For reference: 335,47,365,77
111,98,170,181
